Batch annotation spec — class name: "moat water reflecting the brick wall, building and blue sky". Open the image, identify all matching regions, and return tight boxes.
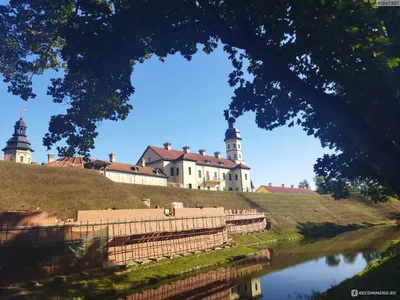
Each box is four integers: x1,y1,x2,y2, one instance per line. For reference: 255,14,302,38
119,227,400,300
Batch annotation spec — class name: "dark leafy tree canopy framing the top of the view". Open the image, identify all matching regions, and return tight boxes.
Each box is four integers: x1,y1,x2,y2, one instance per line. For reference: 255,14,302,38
0,0,400,200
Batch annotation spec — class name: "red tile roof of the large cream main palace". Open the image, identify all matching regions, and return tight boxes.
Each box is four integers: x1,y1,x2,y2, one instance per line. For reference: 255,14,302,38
149,146,250,170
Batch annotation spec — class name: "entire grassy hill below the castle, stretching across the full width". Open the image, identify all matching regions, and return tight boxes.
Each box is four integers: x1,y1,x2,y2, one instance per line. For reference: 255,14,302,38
0,161,400,231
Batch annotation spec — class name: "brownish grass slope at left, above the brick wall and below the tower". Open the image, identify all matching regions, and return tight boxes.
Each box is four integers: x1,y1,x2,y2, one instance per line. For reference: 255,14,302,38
0,161,145,219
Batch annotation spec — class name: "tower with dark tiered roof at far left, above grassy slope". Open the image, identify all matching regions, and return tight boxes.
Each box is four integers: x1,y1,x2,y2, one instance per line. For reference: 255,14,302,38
2,117,34,164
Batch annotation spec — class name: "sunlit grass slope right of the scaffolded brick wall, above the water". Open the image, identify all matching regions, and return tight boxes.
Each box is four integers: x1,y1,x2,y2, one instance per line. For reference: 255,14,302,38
246,193,400,234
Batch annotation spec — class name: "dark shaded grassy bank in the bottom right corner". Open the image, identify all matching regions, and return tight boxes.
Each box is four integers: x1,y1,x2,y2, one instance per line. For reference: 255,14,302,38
318,240,400,300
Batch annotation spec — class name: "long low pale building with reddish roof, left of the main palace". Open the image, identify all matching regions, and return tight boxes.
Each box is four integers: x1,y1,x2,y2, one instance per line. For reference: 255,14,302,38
46,153,168,186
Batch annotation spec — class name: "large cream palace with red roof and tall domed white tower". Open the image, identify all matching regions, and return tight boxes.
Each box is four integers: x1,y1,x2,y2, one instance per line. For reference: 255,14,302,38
138,119,251,192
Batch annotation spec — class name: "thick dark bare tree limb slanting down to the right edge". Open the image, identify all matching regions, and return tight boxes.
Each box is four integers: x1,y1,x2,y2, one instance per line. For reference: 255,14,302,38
200,1,400,188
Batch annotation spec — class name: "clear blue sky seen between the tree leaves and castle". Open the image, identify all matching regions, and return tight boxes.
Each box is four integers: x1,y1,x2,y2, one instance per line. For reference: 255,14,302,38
0,43,329,187
